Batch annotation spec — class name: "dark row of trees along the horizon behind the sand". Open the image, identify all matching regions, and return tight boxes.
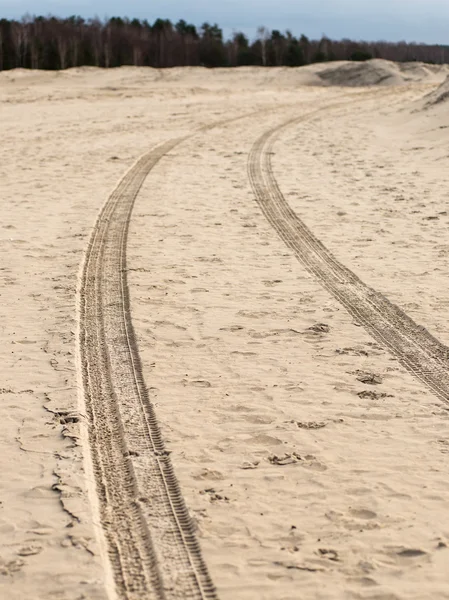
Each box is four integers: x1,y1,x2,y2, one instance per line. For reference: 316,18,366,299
0,16,449,71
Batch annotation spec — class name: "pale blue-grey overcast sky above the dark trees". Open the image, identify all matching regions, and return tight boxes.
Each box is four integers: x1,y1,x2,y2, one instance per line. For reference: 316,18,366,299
0,0,449,44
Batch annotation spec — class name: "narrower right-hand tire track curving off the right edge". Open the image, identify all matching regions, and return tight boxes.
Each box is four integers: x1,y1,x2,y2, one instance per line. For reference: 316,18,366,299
248,106,449,402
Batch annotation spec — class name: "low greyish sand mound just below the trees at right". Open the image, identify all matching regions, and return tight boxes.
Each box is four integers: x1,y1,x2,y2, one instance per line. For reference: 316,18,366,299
312,59,448,87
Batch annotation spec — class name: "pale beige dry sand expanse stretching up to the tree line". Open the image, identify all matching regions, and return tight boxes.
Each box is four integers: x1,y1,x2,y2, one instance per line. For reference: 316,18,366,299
0,61,449,600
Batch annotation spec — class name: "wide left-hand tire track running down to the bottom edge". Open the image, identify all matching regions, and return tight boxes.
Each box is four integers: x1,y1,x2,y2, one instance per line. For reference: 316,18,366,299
79,137,216,600
